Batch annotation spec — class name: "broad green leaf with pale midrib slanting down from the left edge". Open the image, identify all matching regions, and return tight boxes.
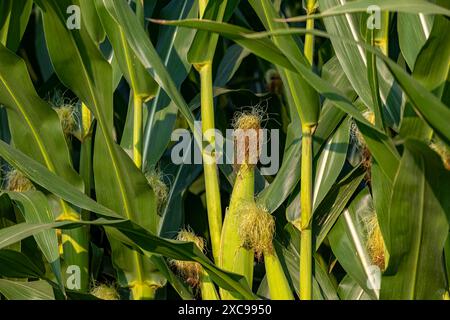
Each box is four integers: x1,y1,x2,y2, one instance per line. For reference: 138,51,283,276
0,45,83,190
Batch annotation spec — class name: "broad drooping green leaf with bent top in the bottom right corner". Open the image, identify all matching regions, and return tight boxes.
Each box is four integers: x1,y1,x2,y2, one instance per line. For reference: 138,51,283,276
381,140,450,300
